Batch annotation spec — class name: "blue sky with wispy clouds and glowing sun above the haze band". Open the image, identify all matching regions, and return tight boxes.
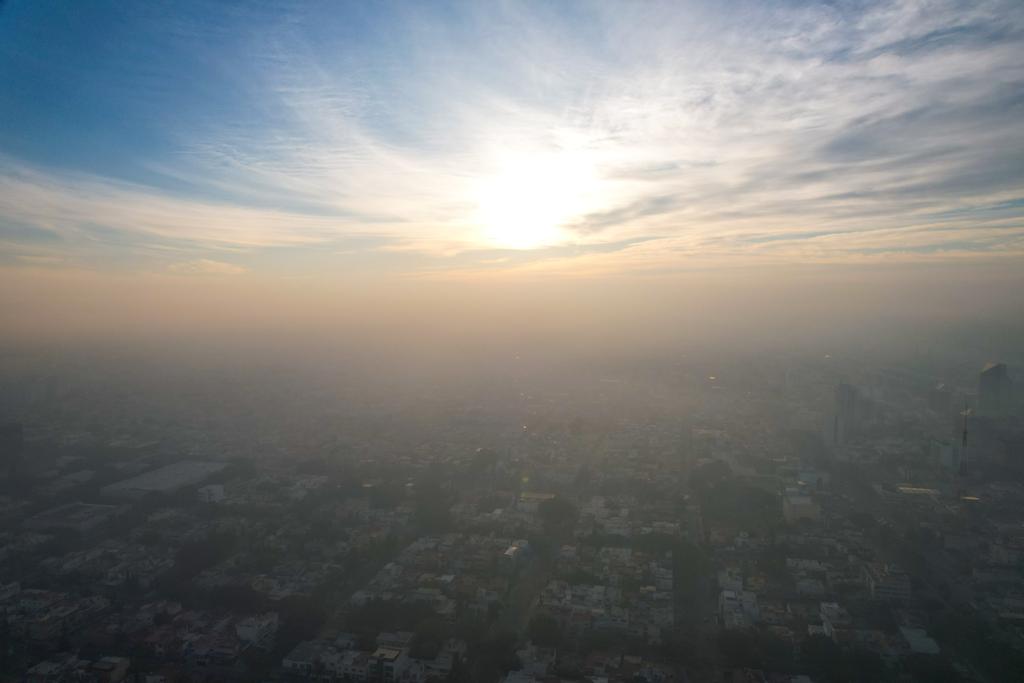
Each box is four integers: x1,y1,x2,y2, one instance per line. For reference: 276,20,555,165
0,0,1024,276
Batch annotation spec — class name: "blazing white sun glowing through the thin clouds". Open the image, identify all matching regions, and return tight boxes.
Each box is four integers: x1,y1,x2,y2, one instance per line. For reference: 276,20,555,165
475,152,596,249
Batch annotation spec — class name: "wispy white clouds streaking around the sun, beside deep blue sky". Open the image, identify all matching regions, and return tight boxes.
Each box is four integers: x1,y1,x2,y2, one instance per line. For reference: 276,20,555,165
0,1,1024,270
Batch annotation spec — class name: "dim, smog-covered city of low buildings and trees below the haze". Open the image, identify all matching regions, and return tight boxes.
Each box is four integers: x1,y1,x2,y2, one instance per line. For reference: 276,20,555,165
0,344,1024,683
